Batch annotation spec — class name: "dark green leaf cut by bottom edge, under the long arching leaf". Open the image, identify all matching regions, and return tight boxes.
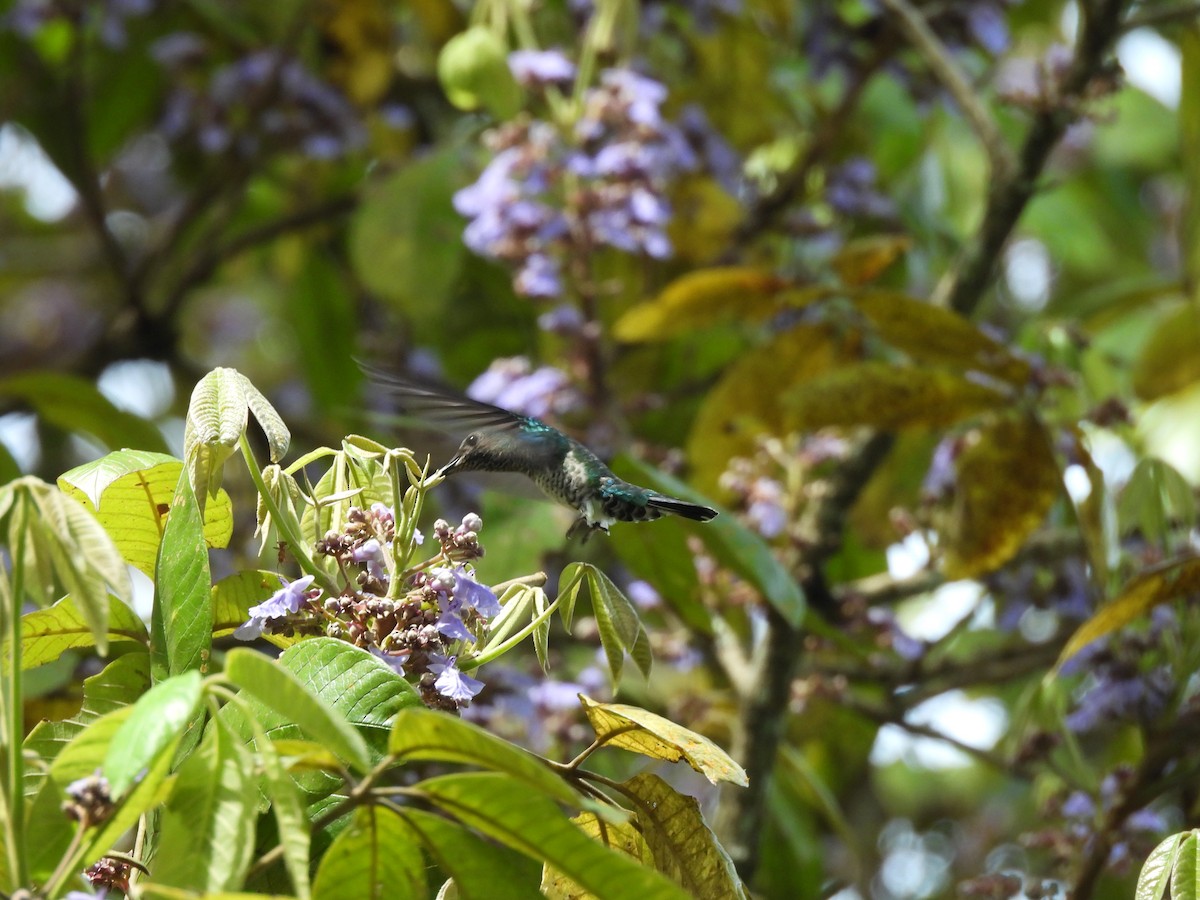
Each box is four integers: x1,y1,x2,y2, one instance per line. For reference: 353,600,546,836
397,806,540,900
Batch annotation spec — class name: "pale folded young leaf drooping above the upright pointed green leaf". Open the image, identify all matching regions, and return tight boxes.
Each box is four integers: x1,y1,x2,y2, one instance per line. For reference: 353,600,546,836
184,368,250,509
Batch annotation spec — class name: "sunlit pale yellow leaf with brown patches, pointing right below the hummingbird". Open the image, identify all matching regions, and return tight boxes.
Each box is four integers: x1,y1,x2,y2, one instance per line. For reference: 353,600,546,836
580,694,750,787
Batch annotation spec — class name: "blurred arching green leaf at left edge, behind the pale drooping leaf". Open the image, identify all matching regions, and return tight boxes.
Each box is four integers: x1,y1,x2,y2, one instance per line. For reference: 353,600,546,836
0,371,167,452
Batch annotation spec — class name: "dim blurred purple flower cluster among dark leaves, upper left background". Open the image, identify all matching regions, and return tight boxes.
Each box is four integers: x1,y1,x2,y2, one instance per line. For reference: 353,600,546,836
152,44,366,160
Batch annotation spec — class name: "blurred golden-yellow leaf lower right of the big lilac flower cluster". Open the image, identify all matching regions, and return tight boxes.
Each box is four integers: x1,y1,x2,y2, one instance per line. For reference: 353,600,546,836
613,266,788,343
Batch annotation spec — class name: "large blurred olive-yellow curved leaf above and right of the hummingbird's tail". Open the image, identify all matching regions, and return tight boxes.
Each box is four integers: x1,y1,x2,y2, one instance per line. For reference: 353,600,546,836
688,325,856,493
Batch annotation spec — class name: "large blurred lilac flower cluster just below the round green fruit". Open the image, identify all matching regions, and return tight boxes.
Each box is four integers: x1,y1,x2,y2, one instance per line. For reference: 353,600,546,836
455,50,698,298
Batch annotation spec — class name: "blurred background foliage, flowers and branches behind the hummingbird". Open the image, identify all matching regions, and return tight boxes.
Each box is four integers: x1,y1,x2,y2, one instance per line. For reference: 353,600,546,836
0,0,1200,900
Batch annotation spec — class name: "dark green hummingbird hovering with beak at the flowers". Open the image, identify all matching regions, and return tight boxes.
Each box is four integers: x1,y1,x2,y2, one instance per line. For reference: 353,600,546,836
359,362,716,541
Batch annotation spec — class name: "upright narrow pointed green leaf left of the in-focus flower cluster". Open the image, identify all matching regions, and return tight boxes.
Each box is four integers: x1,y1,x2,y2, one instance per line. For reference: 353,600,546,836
150,472,212,678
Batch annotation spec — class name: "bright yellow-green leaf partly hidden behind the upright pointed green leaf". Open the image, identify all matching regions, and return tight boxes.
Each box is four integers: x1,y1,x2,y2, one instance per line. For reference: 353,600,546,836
59,450,233,577
